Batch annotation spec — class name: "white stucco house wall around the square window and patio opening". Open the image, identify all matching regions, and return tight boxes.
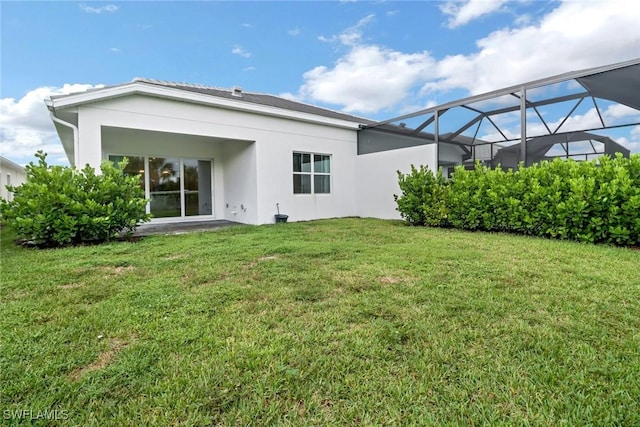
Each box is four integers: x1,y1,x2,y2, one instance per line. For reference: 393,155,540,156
78,95,357,224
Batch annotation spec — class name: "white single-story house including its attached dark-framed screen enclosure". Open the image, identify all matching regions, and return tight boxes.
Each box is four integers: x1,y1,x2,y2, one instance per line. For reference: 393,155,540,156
46,58,640,224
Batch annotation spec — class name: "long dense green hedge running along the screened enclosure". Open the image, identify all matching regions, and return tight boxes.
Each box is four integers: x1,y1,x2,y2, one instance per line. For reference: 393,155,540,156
394,154,640,246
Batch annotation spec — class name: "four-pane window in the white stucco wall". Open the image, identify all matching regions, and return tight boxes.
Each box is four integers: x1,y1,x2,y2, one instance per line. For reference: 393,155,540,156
293,153,331,194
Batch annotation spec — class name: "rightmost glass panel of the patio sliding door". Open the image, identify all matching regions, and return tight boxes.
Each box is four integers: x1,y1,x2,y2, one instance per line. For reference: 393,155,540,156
184,159,213,216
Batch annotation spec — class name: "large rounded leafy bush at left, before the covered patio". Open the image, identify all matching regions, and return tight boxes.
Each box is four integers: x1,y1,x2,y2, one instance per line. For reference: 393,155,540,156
0,151,150,246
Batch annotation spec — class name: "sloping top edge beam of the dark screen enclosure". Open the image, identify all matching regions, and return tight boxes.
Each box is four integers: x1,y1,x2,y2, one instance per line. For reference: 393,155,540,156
369,58,640,127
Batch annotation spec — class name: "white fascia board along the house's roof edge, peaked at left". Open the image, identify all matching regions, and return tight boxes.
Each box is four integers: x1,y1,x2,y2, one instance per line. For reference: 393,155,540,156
46,82,361,129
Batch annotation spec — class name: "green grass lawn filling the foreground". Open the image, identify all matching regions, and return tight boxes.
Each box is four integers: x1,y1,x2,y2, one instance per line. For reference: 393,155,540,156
0,219,640,426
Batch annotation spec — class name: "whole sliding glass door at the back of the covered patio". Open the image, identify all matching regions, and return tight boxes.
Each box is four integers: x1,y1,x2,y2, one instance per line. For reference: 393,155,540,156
109,155,213,218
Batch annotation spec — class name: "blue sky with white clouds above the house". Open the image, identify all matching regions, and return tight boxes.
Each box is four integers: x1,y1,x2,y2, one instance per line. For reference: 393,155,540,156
0,0,640,164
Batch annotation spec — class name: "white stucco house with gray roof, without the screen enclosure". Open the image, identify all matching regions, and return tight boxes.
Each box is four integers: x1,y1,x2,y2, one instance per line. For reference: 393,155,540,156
47,79,435,224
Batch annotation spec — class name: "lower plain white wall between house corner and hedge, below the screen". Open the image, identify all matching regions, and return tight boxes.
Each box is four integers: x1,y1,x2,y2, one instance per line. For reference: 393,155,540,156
356,144,437,219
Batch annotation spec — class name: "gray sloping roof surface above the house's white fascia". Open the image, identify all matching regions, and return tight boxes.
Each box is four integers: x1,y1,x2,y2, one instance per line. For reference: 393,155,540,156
133,77,375,125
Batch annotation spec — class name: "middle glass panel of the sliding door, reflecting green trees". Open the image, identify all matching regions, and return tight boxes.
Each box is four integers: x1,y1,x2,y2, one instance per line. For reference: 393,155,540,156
149,157,182,218
